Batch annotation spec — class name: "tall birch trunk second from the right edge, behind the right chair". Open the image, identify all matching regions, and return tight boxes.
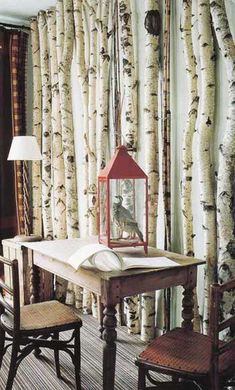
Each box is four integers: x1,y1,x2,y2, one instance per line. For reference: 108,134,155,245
198,0,216,333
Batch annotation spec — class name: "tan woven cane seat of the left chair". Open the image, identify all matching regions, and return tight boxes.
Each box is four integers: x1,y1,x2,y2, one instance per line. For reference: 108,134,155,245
1,301,82,332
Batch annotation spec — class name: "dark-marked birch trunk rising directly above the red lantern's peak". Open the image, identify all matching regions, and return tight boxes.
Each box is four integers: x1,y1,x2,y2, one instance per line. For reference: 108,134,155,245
118,0,138,151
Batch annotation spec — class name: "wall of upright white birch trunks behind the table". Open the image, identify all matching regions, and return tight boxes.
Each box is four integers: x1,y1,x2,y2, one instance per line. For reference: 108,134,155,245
27,0,234,340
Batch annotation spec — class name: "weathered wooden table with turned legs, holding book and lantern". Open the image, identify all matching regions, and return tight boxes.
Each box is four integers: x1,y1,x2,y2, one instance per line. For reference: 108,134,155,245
2,239,204,390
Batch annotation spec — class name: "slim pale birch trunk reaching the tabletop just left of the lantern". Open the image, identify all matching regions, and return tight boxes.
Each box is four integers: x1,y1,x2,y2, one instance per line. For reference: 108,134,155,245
88,0,97,235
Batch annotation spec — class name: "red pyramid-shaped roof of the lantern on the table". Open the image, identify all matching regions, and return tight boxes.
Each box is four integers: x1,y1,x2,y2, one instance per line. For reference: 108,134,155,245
99,145,147,179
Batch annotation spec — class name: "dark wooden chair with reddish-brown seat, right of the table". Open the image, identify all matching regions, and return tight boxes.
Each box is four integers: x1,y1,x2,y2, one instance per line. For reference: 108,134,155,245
135,279,235,390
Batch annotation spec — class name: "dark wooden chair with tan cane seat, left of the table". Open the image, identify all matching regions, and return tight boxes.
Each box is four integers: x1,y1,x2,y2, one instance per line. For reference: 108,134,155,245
0,256,82,390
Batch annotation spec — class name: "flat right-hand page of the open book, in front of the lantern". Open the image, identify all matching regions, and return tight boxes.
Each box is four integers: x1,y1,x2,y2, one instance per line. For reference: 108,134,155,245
123,257,180,269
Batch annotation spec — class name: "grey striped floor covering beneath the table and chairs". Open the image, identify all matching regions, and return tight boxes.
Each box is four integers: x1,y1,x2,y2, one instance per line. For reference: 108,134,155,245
0,316,167,390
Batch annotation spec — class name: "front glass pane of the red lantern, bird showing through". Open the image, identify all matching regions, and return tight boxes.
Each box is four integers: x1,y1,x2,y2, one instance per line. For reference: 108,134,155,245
110,179,146,245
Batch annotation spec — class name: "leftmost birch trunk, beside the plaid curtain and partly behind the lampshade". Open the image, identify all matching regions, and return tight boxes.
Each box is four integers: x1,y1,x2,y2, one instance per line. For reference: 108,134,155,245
30,18,42,235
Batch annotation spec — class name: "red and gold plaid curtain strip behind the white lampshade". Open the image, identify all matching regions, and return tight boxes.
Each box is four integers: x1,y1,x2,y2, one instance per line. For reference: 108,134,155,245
10,31,28,234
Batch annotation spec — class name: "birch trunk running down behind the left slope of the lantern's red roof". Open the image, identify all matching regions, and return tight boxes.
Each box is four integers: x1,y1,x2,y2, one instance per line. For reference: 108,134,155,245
97,0,110,173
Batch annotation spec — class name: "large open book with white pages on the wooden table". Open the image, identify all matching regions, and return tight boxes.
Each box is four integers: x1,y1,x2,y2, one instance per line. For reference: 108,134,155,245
68,244,179,271
